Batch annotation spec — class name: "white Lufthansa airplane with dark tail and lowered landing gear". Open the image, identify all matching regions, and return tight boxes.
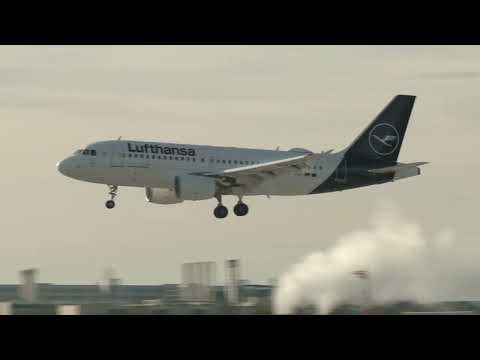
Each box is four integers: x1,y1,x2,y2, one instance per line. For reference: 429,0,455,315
57,95,428,219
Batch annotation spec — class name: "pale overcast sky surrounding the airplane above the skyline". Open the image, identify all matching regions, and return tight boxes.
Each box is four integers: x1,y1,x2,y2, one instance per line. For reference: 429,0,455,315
0,46,480,284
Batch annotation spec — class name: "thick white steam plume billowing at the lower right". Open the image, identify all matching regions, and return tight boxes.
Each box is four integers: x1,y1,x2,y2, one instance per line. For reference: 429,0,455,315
274,205,480,314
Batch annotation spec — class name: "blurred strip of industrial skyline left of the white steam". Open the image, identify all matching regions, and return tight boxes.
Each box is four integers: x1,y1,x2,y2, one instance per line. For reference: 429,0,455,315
0,260,273,315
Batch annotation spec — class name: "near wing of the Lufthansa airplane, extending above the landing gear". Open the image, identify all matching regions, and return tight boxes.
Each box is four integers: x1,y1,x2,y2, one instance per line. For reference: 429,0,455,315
192,153,315,184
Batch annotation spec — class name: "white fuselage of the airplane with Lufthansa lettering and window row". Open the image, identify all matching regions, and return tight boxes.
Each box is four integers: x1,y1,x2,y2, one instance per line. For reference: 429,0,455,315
58,140,344,195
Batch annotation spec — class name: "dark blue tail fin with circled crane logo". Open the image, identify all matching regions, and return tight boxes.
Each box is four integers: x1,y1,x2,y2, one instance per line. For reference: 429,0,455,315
345,95,415,165
